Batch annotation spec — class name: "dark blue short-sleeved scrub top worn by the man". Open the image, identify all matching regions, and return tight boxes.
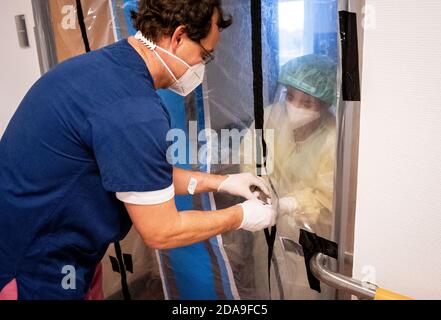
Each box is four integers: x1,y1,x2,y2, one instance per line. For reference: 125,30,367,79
0,40,173,299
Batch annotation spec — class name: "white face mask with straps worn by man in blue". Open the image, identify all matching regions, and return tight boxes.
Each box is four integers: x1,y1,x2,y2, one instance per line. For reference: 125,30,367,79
135,31,205,97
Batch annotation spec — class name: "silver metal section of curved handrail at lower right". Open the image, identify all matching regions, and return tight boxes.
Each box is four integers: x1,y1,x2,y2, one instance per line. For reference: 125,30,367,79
309,253,377,300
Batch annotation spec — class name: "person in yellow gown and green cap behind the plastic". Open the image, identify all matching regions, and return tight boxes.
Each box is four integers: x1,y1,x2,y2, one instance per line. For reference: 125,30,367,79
241,54,337,299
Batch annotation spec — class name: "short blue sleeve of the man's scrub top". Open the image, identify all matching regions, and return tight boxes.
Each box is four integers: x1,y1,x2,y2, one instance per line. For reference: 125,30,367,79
89,96,173,193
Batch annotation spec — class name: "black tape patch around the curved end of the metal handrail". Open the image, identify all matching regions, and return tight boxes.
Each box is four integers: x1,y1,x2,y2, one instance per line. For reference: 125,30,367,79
299,230,338,292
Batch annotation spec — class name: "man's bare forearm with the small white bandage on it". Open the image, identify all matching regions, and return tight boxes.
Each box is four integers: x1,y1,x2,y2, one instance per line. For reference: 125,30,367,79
173,168,227,195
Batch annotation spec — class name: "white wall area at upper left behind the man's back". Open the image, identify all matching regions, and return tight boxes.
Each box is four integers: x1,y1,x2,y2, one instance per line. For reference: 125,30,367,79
0,0,40,137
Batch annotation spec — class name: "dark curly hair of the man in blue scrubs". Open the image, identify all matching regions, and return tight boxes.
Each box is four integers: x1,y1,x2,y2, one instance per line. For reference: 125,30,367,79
131,0,233,42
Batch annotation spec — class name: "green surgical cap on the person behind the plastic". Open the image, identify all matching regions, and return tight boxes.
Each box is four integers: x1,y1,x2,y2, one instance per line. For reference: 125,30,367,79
279,54,337,105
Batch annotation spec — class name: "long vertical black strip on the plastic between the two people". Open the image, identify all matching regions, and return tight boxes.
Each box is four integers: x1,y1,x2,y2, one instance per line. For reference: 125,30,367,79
251,0,277,297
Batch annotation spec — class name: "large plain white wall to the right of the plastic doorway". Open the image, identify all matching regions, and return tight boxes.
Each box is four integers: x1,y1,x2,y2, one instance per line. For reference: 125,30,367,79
354,0,441,299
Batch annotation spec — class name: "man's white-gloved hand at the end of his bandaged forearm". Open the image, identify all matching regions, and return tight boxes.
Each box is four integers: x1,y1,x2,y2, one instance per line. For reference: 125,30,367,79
218,173,271,200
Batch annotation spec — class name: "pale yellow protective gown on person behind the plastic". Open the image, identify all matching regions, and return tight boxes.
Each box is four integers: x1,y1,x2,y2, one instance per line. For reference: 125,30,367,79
242,103,337,299
